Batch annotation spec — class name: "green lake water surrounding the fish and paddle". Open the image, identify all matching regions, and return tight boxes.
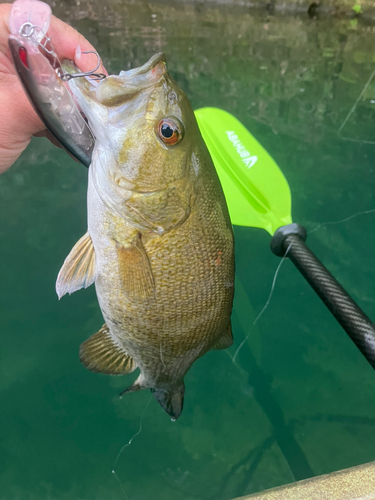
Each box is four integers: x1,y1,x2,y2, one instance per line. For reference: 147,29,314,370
0,0,375,500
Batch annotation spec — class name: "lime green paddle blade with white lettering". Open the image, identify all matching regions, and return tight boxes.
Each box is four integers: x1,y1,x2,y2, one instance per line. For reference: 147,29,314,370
195,108,292,235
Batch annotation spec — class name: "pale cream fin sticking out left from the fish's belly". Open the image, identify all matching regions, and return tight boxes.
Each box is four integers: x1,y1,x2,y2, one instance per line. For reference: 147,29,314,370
56,233,96,299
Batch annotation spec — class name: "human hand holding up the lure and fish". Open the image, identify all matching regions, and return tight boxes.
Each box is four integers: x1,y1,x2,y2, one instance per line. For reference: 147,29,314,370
0,4,105,174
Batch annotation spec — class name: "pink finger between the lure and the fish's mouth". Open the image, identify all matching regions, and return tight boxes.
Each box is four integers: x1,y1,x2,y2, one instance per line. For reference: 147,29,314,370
48,16,108,75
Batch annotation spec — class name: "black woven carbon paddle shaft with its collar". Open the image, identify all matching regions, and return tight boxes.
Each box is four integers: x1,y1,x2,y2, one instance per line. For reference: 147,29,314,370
271,224,375,368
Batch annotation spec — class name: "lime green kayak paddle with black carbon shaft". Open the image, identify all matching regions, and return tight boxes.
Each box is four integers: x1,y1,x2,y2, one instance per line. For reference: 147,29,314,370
195,108,375,368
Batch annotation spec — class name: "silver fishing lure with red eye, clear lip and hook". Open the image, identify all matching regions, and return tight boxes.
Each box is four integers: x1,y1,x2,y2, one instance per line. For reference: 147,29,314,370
8,0,105,167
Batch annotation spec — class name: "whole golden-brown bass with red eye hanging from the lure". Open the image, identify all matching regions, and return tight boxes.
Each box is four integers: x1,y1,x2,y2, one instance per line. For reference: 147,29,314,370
56,53,234,420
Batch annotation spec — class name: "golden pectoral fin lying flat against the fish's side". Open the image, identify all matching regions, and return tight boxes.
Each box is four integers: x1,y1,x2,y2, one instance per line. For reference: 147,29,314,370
117,233,155,299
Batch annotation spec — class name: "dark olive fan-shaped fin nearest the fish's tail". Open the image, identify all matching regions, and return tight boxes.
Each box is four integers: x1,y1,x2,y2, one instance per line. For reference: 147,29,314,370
79,324,137,375
